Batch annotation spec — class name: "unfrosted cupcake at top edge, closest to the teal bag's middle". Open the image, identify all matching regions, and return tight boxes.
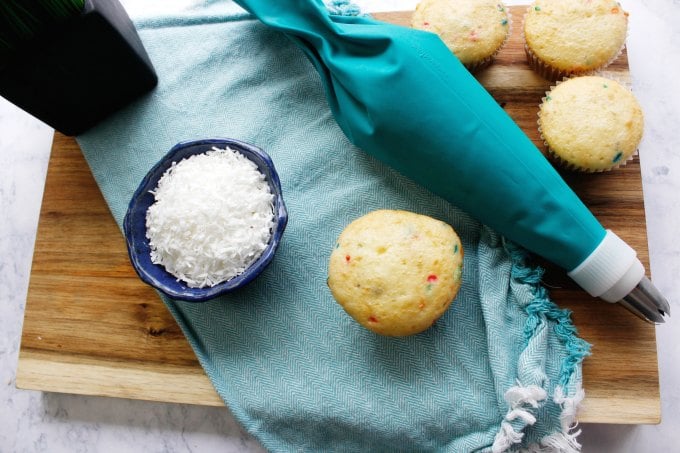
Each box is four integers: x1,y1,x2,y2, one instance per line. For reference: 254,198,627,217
411,0,510,71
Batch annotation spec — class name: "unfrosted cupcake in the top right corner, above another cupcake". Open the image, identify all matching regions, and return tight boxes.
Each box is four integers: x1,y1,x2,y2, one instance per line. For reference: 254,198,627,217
524,0,628,81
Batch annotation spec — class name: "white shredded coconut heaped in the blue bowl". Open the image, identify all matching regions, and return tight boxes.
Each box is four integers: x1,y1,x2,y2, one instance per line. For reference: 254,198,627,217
146,148,274,288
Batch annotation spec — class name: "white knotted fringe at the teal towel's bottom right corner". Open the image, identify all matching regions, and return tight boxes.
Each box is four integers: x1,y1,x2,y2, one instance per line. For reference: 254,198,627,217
491,385,585,453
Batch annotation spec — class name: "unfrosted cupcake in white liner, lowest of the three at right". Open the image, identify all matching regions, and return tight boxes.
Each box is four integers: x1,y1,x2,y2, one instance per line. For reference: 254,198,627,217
538,76,644,172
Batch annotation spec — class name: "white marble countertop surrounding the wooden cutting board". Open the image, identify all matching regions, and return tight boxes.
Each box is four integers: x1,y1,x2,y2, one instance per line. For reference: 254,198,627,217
0,0,680,453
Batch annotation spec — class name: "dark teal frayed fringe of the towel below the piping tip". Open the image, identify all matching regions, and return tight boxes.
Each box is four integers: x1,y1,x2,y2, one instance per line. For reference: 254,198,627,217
505,242,590,387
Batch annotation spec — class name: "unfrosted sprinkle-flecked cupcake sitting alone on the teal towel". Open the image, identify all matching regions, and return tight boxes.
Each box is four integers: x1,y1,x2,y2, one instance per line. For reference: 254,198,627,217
328,209,463,336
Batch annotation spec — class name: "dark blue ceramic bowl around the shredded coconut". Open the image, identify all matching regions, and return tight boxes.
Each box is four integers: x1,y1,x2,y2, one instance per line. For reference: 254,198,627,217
123,139,288,302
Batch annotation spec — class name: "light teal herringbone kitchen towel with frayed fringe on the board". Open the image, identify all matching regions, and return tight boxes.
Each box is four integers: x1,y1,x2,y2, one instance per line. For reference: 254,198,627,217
77,1,589,452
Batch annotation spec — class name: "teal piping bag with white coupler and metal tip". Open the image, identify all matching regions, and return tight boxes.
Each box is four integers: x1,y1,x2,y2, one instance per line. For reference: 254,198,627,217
236,0,670,322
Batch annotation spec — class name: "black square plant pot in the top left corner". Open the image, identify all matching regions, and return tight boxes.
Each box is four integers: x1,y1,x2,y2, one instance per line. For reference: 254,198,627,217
0,0,158,135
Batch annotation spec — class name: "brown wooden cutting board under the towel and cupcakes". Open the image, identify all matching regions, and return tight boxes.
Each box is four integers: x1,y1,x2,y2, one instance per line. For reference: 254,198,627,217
16,7,660,423
